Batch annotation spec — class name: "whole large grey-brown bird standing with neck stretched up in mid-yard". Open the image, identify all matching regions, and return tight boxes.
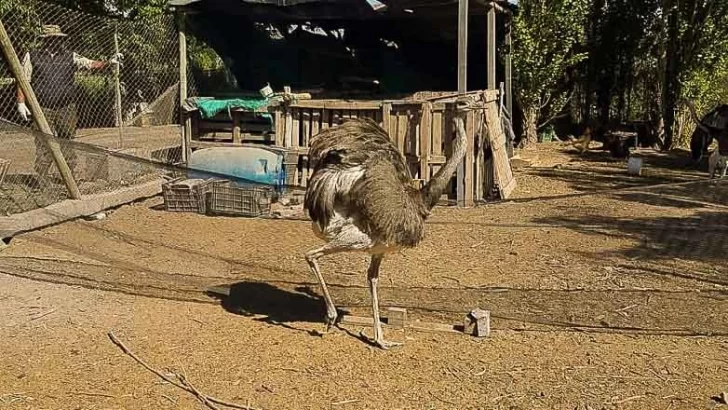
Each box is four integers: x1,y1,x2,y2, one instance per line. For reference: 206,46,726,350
304,98,473,349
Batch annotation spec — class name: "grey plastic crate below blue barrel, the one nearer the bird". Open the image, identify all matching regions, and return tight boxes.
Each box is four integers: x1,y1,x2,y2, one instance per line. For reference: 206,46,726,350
207,181,274,217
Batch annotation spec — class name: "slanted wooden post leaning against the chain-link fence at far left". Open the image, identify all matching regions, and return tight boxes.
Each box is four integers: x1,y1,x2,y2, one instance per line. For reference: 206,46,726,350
0,20,81,199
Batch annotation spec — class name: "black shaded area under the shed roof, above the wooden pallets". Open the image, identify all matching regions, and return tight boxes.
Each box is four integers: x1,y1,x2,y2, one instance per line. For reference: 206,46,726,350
168,0,503,95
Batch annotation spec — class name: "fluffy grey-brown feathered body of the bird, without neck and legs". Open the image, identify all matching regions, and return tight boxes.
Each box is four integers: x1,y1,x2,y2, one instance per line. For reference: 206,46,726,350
305,119,428,247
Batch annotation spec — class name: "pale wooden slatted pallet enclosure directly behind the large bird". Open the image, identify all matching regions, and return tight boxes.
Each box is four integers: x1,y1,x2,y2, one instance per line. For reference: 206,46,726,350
269,90,515,206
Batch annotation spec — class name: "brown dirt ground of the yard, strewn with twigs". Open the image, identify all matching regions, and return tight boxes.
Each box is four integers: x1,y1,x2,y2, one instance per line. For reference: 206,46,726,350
0,144,728,410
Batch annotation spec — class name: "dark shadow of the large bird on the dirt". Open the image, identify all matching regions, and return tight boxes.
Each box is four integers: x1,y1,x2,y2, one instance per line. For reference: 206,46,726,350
205,281,348,336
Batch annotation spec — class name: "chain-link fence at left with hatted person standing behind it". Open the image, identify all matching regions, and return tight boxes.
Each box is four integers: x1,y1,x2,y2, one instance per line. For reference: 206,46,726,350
0,0,193,215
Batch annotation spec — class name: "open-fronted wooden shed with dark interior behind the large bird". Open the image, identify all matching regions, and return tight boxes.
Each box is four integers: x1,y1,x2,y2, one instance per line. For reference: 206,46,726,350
169,0,515,206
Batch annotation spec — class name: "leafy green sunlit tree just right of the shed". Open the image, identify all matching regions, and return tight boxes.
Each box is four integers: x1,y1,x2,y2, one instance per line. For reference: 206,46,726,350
512,0,589,144
